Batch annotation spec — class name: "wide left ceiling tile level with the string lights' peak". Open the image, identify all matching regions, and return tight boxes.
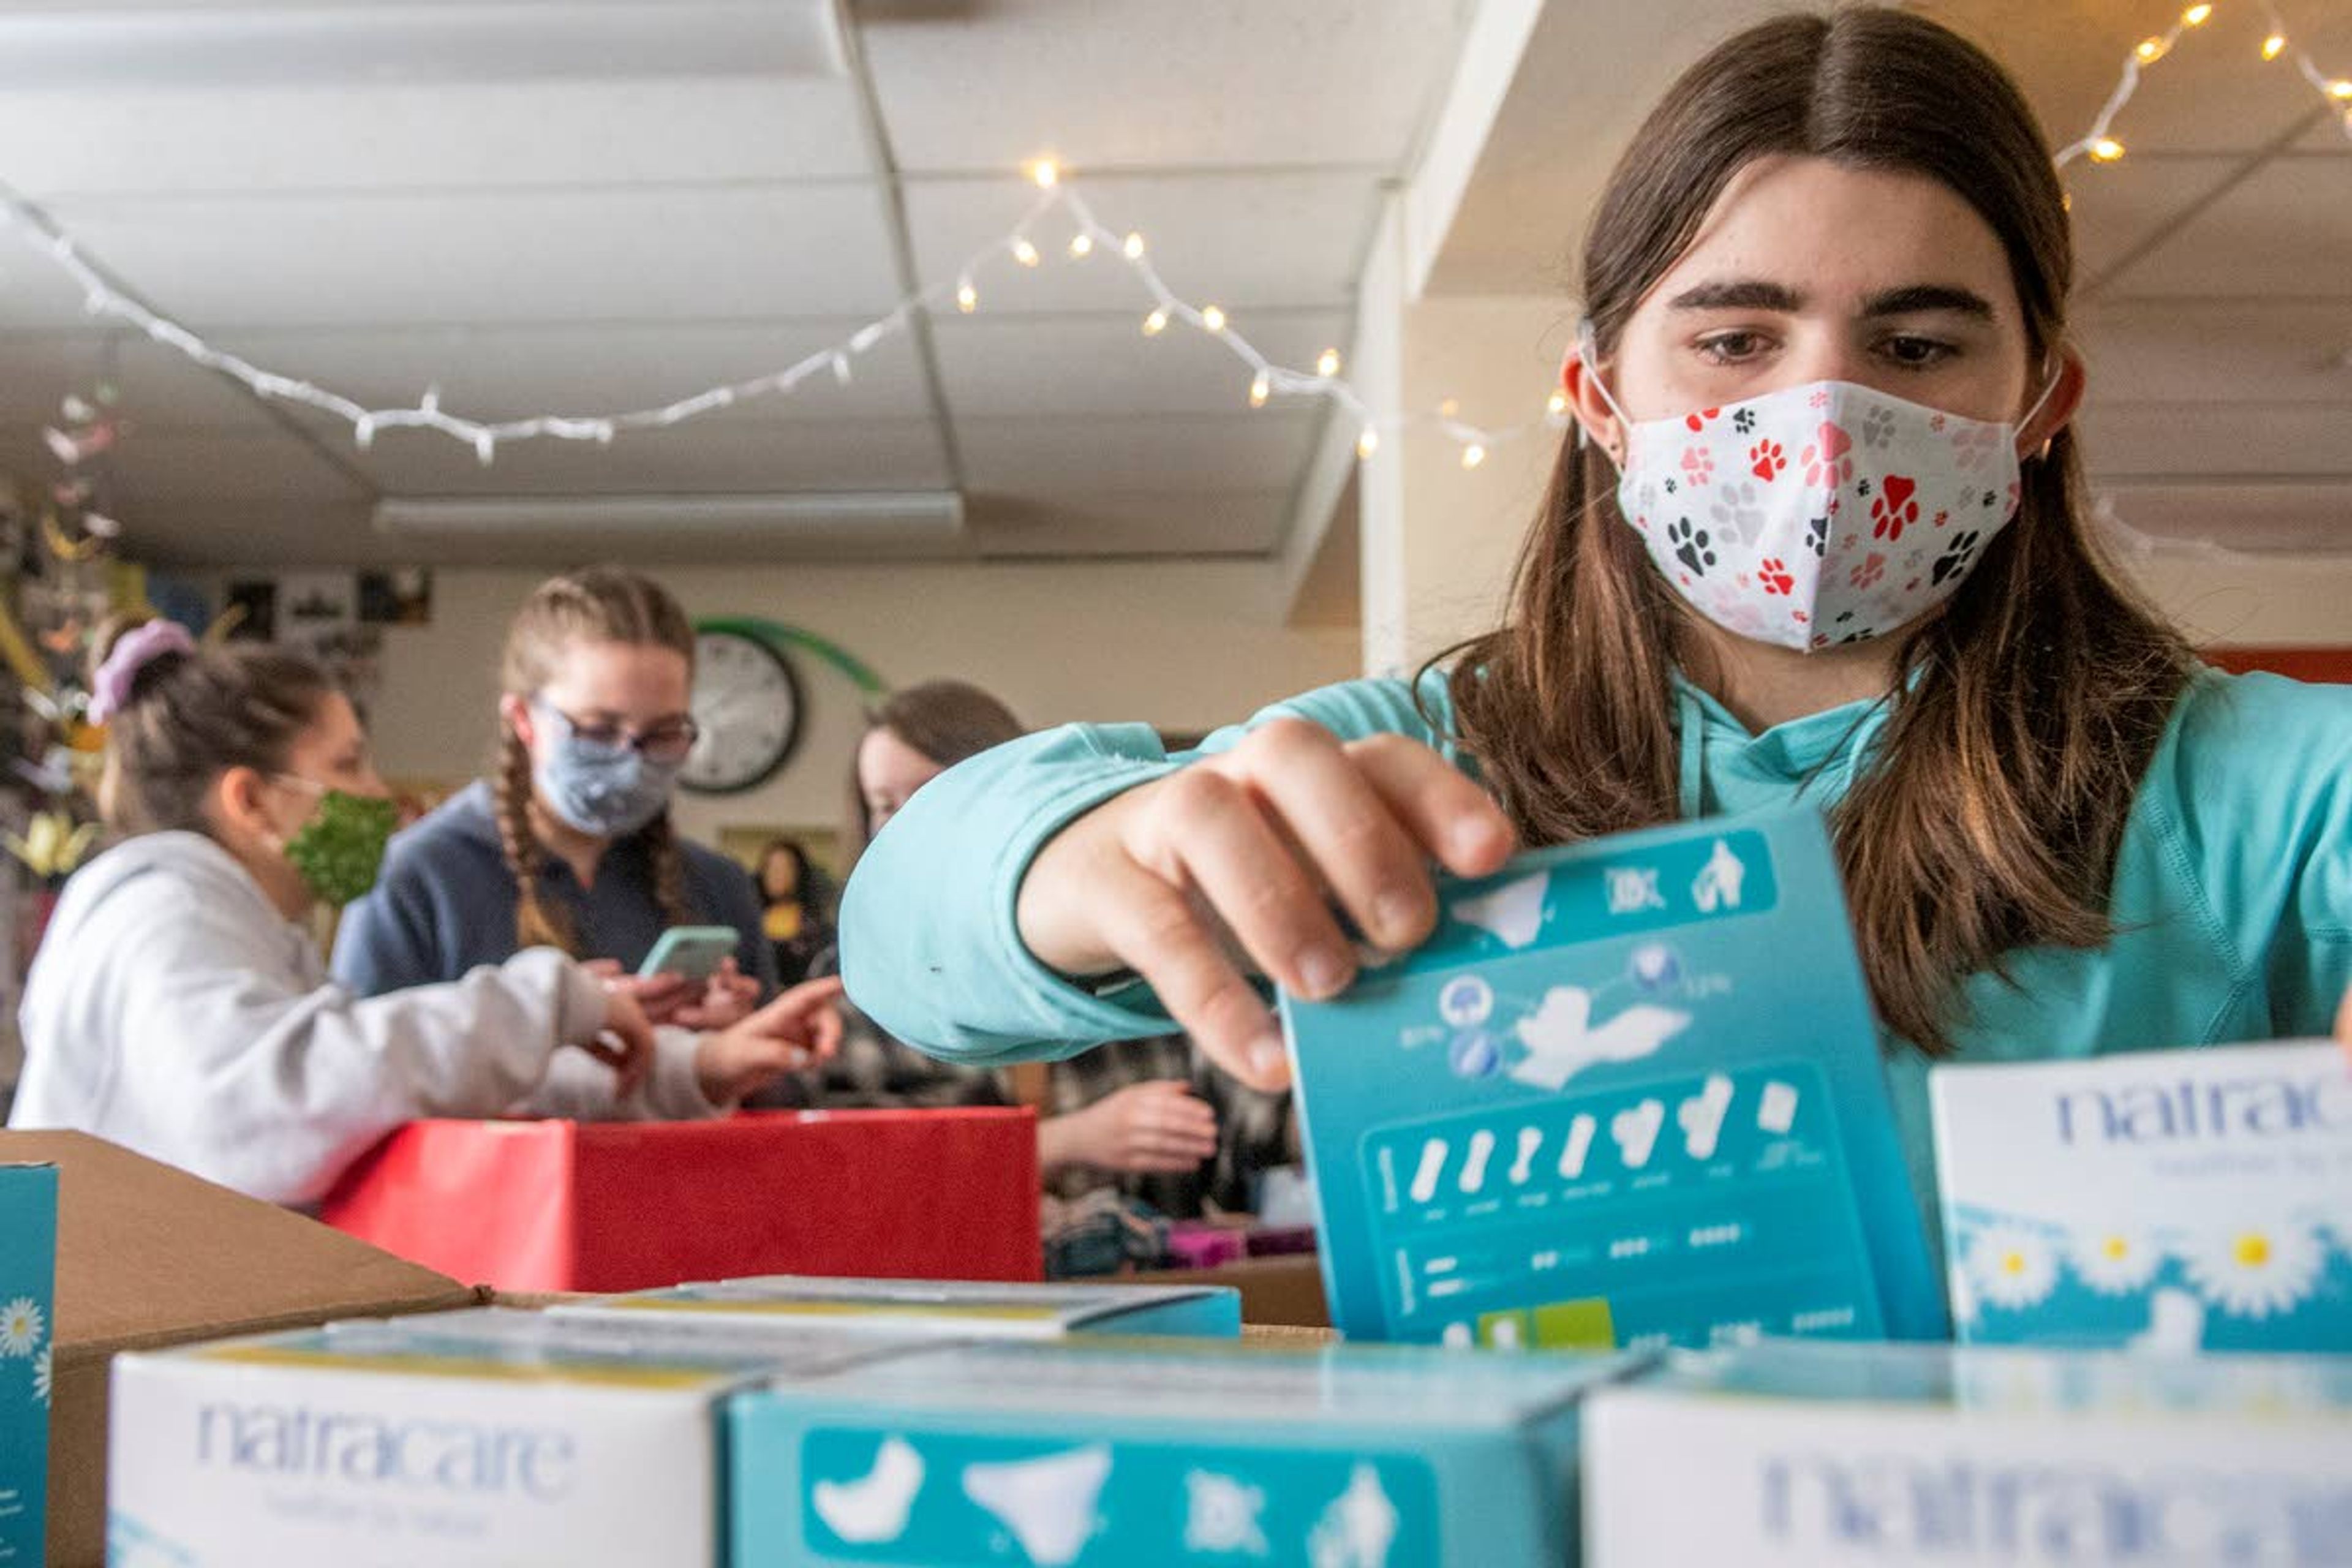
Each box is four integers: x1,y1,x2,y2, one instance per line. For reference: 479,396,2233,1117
56,186,896,326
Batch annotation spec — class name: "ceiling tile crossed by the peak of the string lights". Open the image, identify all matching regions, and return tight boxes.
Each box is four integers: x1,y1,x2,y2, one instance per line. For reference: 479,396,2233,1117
905,174,1381,315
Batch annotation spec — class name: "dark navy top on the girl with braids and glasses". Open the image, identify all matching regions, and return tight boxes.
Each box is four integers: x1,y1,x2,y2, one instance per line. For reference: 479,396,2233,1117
334,780,776,997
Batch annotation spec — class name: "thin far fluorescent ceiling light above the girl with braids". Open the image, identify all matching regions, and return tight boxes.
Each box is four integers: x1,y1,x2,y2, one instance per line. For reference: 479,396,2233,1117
376,489,964,543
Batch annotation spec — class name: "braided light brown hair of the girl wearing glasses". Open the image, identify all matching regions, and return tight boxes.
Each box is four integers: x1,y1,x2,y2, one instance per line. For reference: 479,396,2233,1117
492,567,694,954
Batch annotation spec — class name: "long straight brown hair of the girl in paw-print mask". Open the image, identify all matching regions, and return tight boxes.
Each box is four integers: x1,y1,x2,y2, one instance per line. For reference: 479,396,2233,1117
1453,7,2192,1053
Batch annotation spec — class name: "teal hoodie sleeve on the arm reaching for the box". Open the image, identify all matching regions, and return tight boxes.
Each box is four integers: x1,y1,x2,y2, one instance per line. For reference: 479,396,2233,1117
840,673,1451,1065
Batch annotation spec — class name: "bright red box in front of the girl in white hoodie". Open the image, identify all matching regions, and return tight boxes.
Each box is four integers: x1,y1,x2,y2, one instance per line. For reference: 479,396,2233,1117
320,1110,1044,1291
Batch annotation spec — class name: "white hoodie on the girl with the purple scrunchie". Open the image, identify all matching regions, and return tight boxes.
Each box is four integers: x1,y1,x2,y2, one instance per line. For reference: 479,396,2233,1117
9,832,717,1204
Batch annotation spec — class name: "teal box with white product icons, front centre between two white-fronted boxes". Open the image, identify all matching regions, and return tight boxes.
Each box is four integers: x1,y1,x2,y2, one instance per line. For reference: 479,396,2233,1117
727,1340,1642,1568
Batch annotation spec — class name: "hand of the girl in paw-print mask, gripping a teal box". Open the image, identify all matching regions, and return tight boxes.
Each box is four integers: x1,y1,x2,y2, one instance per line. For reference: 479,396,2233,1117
1016,719,1515,1091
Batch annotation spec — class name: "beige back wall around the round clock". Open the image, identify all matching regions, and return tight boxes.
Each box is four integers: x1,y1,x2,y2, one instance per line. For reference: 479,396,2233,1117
334,562,1357,860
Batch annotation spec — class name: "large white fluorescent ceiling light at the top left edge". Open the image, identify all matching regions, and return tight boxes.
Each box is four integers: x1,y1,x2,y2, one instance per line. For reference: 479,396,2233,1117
0,0,845,89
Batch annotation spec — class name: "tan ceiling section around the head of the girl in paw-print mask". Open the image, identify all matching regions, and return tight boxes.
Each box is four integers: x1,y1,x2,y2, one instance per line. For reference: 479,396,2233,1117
1430,0,2352,564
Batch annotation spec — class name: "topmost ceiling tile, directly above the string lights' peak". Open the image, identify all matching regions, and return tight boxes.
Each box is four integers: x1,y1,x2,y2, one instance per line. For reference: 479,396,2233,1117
859,0,1470,172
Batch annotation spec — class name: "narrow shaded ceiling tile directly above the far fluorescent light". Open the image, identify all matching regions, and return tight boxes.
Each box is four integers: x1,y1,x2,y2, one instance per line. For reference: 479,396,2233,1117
334,418,948,496
